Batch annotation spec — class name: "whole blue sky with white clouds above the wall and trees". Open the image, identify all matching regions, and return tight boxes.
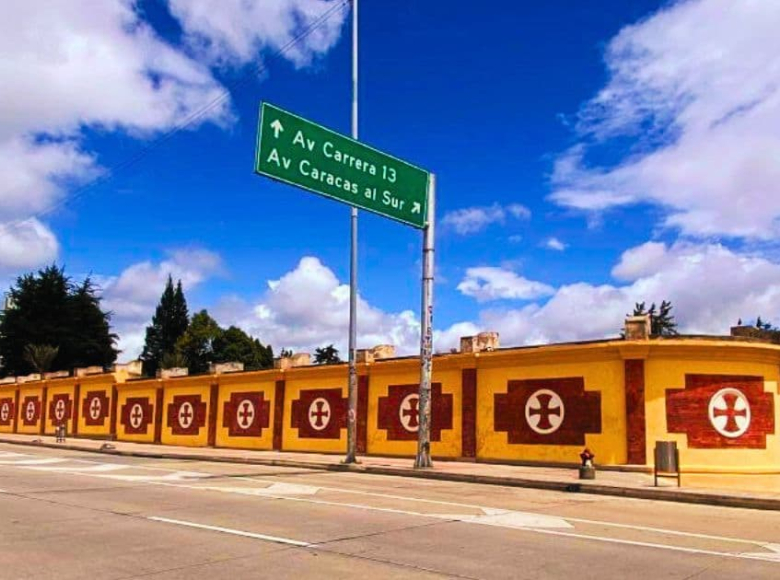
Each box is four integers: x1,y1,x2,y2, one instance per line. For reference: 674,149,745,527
0,0,780,358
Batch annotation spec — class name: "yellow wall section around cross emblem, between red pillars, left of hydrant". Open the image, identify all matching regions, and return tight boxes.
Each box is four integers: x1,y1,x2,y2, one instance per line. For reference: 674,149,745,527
477,344,627,464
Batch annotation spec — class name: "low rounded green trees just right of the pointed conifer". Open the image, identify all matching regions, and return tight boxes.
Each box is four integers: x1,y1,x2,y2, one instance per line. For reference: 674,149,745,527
176,310,274,374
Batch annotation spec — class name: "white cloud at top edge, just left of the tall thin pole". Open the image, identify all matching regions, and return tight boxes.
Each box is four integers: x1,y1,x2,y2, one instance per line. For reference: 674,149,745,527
168,0,348,66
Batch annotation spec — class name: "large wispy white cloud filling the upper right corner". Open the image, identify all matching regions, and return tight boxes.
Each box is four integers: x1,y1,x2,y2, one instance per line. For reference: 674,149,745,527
552,0,780,239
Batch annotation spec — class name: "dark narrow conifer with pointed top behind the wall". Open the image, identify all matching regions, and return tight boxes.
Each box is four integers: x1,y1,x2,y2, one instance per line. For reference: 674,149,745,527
141,276,189,376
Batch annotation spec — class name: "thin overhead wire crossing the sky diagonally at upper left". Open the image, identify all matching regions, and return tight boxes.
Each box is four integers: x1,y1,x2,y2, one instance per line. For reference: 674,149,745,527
0,0,350,238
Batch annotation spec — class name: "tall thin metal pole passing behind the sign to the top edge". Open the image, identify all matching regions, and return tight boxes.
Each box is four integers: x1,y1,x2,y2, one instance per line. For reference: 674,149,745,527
344,0,358,463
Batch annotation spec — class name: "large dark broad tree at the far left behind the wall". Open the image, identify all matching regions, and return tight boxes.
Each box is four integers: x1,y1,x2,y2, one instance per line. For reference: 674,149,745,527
0,265,117,375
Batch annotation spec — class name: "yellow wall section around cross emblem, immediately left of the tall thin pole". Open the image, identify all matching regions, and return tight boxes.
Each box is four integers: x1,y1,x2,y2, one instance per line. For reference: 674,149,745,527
282,365,348,453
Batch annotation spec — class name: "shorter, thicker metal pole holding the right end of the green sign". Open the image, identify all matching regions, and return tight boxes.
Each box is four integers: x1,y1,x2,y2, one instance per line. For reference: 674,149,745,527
414,173,436,468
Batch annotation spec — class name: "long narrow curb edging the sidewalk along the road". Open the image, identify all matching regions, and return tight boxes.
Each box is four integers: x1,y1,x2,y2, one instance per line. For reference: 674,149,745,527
0,437,780,511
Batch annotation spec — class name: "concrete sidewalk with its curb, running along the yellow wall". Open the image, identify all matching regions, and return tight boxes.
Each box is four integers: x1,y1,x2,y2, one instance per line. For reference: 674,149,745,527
0,433,780,511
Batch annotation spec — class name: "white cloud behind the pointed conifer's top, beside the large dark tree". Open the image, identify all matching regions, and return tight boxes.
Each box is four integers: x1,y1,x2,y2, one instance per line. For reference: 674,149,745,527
94,249,223,360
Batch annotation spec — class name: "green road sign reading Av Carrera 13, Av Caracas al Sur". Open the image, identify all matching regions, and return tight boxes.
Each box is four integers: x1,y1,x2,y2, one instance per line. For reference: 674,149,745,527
255,103,429,228
